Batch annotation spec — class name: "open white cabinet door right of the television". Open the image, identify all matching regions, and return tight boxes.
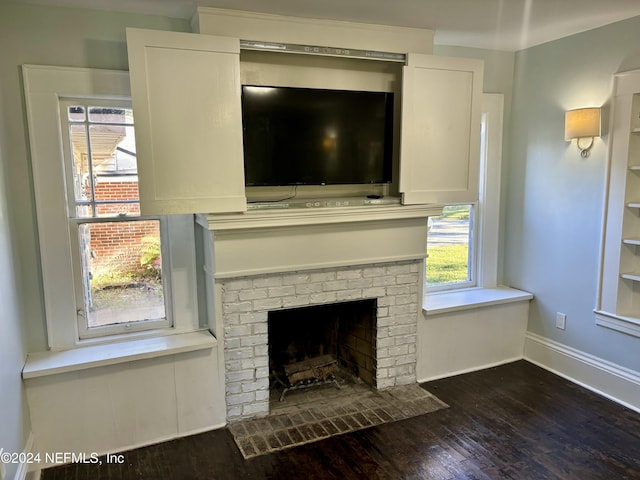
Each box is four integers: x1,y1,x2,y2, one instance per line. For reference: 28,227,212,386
400,54,483,204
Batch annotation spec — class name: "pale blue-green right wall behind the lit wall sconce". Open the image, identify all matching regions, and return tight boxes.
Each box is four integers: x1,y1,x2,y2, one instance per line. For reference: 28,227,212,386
504,17,640,372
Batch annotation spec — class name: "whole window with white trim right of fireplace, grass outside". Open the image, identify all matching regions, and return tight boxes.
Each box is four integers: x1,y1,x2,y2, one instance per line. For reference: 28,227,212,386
425,94,503,294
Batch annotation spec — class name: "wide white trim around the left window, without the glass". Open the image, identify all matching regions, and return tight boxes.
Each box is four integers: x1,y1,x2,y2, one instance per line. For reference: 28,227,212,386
23,65,201,350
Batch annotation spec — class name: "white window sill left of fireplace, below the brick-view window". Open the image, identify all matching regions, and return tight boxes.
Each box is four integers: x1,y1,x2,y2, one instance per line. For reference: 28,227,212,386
22,330,217,379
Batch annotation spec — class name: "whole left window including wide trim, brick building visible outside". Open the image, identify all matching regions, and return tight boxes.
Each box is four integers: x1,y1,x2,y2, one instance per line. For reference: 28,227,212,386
23,65,200,350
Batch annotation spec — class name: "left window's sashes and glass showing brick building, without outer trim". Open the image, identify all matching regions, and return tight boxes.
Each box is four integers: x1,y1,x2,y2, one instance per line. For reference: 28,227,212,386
60,99,171,338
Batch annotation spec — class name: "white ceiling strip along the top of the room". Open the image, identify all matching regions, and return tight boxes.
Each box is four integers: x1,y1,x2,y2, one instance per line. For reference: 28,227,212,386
13,0,640,51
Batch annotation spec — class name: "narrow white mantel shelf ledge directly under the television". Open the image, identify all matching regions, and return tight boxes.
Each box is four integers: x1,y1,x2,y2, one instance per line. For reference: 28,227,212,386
207,204,443,231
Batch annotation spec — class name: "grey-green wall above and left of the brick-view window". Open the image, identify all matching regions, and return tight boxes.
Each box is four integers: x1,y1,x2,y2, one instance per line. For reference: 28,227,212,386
0,4,190,351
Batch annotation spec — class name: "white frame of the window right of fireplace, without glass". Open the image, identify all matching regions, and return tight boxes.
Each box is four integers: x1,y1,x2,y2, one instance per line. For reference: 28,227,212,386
424,93,504,296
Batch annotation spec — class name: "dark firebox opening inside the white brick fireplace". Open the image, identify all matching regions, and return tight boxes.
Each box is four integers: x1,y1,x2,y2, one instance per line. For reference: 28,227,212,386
268,299,377,398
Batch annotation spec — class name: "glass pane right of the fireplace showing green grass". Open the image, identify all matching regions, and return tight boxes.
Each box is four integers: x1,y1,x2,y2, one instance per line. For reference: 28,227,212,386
427,205,473,287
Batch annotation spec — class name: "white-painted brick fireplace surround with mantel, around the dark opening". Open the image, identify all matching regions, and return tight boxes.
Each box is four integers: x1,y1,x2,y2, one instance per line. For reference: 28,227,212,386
207,205,441,422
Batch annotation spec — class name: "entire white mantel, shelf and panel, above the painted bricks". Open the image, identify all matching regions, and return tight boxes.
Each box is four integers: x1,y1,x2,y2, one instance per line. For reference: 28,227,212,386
201,205,442,279
